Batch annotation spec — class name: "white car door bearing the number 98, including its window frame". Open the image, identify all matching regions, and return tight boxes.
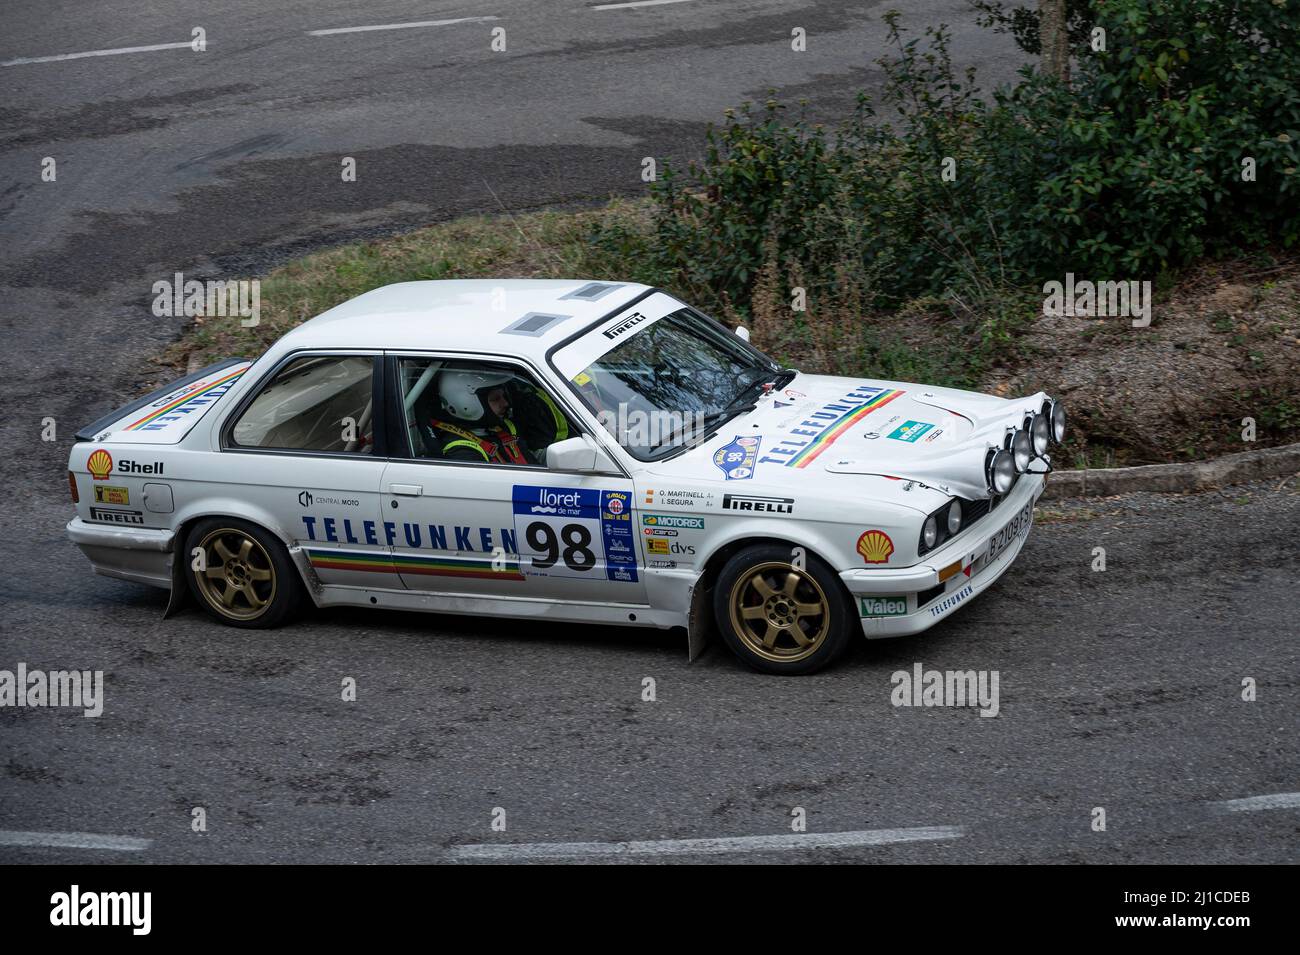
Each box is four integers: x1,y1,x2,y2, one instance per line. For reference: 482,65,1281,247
381,353,646,605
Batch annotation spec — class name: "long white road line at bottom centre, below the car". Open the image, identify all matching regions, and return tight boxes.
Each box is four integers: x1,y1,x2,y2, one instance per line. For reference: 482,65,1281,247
449,825,963,860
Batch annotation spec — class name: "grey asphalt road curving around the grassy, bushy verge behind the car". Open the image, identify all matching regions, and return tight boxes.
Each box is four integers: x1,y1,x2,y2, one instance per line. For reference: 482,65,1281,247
0,0,1300,864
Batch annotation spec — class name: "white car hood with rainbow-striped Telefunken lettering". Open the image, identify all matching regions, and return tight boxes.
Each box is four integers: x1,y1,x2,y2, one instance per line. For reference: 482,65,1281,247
650,374,1045,509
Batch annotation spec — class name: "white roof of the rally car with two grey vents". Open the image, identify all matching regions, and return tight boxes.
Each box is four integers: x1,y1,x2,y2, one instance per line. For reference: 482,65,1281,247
273,279,650,361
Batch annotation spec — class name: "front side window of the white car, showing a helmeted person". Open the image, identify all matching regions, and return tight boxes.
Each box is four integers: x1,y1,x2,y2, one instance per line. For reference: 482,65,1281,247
398,357,579,466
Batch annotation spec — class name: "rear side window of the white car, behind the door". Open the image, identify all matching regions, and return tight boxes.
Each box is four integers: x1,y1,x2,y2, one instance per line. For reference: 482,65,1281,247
230,355,374,455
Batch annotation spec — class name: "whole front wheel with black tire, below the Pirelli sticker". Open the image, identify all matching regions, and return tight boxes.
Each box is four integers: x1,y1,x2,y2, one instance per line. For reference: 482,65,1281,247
714,544,861,676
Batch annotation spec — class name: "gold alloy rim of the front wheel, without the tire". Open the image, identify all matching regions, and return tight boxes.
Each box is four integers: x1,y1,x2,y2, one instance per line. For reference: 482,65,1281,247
729,561,831,663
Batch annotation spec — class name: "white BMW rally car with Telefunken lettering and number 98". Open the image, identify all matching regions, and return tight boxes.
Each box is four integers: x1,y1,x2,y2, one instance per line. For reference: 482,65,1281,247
68,281,1065,673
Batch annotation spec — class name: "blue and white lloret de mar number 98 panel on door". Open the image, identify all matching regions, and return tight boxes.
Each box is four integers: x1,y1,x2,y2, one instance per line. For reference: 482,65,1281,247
512,485,637,582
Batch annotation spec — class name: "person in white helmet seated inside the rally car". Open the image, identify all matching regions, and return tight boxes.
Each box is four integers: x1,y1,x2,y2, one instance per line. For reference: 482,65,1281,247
421,369,530,464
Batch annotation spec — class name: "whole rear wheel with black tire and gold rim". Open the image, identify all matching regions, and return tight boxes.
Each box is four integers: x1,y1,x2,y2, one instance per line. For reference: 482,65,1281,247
179,517,304,629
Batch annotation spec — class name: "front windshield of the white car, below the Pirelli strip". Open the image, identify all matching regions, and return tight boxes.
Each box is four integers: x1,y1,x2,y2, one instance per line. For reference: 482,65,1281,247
569,308,781,461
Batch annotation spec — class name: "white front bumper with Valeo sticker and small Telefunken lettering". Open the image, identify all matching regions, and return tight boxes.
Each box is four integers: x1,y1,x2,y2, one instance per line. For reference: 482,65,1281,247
840,474,1047,639
